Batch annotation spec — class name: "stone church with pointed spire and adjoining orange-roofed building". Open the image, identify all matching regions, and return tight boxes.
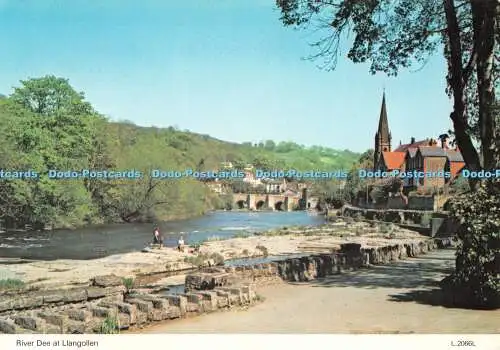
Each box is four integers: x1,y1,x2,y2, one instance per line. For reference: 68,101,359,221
373,91,465,191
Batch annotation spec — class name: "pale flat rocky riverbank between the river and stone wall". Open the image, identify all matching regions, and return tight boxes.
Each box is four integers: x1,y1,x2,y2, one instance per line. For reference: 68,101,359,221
0,219,428,289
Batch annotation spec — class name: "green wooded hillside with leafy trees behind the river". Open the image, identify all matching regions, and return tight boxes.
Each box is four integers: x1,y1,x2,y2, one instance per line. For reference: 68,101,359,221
0,76,358,227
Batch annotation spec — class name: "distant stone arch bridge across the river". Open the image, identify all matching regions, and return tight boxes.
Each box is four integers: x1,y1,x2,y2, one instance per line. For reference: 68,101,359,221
233,193,308,211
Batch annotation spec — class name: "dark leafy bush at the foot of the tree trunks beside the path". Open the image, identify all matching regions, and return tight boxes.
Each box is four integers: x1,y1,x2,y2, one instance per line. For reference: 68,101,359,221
442,181,500,308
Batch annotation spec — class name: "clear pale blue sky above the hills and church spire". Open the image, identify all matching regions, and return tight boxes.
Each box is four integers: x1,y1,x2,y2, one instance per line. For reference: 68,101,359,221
0,0,451,151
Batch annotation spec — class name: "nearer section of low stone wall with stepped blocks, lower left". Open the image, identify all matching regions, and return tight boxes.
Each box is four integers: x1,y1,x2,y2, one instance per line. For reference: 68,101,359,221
0,275,256,334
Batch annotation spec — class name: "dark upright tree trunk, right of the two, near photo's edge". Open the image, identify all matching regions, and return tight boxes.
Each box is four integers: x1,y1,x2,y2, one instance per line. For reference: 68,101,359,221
471,0,499,169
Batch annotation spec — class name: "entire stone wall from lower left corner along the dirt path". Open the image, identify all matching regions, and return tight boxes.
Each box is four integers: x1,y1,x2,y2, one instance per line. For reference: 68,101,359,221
0,238,454,334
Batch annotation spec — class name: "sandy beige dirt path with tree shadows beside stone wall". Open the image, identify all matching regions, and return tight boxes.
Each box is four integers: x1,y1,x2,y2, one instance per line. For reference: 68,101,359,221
141,250,500,333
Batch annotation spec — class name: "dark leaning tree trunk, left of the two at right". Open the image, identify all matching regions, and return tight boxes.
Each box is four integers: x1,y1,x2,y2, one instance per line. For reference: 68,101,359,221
443,0,481,188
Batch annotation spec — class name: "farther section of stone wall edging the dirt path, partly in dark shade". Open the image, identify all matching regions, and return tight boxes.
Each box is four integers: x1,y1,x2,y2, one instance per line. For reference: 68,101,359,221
186,238,455,290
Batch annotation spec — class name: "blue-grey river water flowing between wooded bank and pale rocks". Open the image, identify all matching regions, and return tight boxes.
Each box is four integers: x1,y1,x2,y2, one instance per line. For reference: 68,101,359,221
0,211,324,260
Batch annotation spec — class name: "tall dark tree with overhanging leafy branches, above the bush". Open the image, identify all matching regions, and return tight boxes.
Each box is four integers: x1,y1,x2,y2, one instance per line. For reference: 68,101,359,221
277,0,500,185
